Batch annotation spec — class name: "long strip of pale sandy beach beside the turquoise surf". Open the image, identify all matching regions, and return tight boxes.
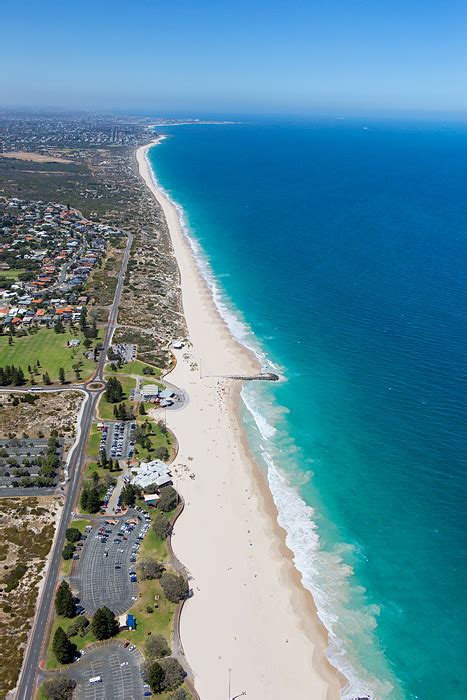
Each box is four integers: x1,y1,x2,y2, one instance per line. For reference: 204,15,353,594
137,139,344,700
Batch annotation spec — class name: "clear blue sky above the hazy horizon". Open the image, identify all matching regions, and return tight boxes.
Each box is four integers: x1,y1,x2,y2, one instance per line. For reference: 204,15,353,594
0,0,467,114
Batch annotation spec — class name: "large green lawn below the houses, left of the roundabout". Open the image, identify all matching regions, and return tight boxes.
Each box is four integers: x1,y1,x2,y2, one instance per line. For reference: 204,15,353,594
0,328,96,384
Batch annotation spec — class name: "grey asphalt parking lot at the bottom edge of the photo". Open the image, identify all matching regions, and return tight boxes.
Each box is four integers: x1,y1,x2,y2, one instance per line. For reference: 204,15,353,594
73,642,146,700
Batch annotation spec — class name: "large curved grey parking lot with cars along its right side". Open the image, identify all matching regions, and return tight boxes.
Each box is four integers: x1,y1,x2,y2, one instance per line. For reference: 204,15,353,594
70,510,149,615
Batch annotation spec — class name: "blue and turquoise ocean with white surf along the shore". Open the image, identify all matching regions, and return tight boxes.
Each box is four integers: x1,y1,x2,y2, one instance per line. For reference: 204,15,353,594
149,118,467,700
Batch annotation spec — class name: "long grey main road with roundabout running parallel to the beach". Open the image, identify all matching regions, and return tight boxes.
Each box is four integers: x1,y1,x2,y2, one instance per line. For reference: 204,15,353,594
16,235,133,700
